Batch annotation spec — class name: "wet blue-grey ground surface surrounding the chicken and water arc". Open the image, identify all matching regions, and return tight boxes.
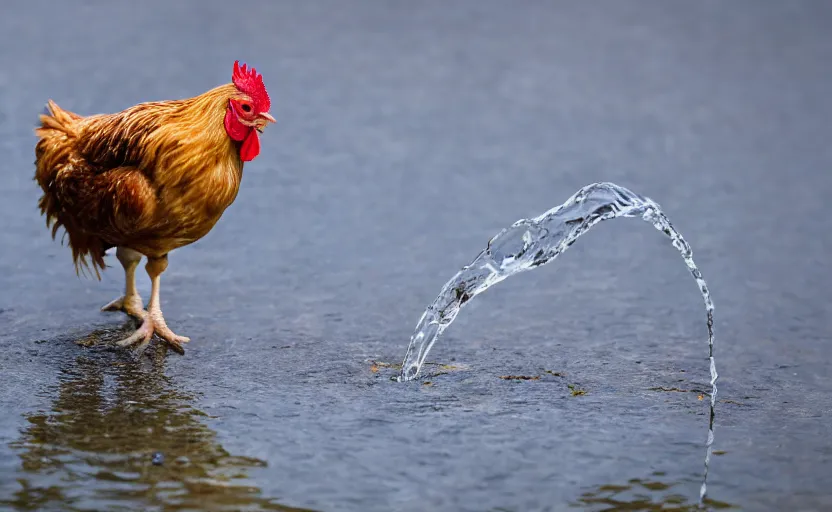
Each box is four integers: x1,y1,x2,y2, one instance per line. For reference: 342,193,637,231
0,0,832,511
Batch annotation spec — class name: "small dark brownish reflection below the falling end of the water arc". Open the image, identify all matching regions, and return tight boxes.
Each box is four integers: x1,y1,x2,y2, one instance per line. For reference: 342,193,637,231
571,472,737,512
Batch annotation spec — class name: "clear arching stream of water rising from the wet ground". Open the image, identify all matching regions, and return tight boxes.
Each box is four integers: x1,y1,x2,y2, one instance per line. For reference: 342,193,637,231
397,183,718,502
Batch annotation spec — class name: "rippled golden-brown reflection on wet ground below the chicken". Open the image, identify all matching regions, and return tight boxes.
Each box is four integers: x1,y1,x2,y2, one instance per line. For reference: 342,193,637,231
0,330,312,511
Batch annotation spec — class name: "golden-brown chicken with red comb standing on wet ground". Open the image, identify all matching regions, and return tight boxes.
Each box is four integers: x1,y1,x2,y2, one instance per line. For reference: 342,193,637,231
35,61,275,353
